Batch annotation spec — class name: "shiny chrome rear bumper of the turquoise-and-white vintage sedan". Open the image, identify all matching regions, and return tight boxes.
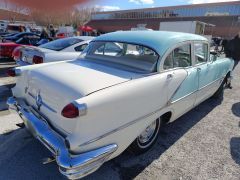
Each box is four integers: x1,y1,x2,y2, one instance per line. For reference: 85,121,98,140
7,97,117,179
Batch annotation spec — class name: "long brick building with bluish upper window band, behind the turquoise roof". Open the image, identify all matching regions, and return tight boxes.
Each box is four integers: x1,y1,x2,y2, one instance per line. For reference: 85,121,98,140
87,1,240,38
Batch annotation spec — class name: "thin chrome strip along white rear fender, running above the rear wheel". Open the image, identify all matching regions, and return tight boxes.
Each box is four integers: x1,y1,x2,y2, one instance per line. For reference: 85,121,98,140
79,105,167,147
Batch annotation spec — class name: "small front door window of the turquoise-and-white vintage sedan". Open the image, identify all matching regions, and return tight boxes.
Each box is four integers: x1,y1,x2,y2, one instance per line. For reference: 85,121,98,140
194,43,208,64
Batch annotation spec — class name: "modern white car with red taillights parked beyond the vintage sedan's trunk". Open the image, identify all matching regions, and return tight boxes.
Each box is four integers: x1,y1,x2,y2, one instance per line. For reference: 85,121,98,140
14,36,94,66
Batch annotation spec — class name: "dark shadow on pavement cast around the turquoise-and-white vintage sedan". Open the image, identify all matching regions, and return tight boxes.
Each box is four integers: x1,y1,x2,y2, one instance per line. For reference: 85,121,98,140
0,99,221,180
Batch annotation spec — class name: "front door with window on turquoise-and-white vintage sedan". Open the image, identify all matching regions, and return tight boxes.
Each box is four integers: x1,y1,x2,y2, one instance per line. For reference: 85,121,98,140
193,42,217,105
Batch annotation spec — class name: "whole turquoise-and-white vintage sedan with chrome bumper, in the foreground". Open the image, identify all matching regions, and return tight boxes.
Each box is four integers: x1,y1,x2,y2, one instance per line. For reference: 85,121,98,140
7,31,233,179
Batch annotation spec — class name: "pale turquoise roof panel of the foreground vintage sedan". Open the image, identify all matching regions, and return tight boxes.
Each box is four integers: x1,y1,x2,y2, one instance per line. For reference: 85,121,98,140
94,31,207,56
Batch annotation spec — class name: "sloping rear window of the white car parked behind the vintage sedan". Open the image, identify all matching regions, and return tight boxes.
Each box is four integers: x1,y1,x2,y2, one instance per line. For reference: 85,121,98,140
39,38,83,51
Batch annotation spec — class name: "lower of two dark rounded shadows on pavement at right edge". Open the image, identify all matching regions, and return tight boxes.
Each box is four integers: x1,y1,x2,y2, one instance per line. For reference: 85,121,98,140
230,137,240,165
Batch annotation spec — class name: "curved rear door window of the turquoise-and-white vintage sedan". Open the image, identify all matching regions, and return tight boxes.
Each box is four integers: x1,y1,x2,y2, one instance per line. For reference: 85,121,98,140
163,44,192,70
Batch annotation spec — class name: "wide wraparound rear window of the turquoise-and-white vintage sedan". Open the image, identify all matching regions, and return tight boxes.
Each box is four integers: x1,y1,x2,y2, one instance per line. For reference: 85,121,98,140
81,41,159,73
